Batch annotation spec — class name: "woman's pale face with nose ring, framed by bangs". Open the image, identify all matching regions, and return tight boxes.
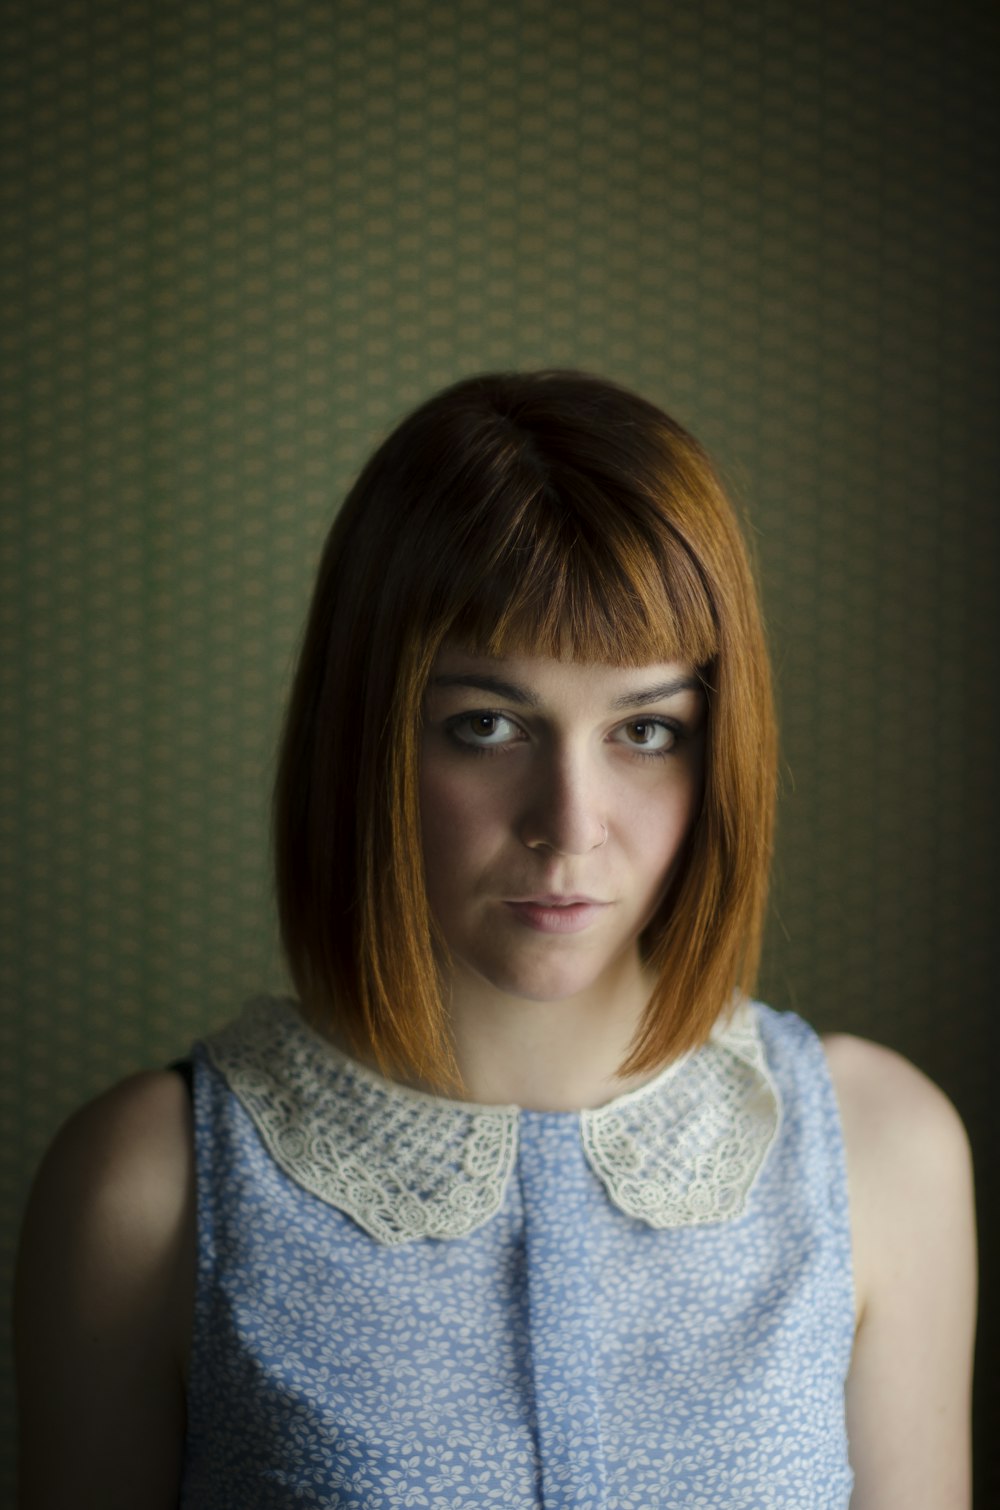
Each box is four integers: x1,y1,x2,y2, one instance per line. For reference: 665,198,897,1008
420,646,705,1001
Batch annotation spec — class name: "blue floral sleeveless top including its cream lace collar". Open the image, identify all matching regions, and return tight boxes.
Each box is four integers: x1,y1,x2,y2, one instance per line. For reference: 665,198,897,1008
181,998,853,1510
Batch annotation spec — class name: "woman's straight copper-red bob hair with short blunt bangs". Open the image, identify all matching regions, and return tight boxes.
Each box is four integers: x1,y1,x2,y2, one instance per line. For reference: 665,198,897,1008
273,371,776,1090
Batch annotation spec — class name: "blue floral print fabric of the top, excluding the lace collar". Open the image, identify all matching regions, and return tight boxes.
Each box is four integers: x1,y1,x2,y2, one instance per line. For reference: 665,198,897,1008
181,1007,853,1510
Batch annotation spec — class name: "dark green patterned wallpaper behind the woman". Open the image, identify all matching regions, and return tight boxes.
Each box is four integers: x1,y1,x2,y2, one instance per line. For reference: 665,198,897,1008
0,0,1000,1487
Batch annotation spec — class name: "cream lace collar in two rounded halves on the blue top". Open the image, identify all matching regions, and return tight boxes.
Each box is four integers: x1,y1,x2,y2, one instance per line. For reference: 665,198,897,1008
205,997,779,1244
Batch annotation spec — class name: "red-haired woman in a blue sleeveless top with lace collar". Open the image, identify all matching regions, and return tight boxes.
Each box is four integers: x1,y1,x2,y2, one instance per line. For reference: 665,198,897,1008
18,373,974,1510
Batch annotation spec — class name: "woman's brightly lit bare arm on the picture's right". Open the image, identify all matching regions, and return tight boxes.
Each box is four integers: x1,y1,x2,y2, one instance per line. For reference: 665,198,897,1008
826,1037,976,1510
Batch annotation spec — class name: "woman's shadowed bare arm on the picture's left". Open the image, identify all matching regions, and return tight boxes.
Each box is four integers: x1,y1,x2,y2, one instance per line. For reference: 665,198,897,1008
14,1072,195,1510
